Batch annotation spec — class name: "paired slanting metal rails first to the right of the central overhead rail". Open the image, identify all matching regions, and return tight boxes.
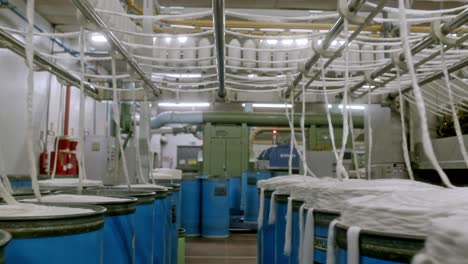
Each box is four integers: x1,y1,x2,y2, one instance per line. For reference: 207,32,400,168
284,0,387,98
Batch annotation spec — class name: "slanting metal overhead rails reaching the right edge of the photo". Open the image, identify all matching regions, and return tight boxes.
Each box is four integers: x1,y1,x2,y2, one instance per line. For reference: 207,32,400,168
350,10,468,98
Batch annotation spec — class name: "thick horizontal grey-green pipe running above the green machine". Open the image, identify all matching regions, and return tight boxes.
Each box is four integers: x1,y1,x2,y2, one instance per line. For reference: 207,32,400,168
150,111,364,129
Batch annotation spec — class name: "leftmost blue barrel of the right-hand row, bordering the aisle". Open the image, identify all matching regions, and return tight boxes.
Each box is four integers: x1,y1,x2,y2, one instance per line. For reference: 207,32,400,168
257,190,275,264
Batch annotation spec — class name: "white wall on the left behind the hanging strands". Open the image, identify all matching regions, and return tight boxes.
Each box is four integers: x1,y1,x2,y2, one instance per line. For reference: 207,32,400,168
0,6,108,175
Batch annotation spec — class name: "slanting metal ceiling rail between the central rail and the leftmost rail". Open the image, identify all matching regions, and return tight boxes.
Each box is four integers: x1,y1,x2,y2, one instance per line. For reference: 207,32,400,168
71,0,160,97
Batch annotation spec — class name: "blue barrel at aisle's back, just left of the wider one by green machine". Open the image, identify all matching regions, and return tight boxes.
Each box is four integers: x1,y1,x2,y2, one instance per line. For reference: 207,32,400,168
180,174,201,236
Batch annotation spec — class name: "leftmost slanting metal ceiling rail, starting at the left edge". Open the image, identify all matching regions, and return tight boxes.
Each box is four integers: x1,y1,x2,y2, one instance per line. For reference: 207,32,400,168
0,29,99,100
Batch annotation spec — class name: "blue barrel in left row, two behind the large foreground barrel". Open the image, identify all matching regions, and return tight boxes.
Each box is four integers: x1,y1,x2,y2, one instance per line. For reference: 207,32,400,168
83,188,156,264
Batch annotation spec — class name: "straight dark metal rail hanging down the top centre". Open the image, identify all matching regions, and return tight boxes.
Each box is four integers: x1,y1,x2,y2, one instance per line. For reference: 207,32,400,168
212,0,226,98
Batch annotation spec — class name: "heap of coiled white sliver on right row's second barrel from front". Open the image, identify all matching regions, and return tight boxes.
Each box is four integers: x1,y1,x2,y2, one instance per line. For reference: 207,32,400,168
340,188,468,236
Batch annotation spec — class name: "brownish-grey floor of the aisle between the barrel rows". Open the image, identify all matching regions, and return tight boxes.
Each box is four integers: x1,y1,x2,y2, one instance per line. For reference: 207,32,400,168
185,232,257,264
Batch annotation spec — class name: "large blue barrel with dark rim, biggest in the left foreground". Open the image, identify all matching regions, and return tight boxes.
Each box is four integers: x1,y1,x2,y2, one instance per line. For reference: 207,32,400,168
0,205,105,264
